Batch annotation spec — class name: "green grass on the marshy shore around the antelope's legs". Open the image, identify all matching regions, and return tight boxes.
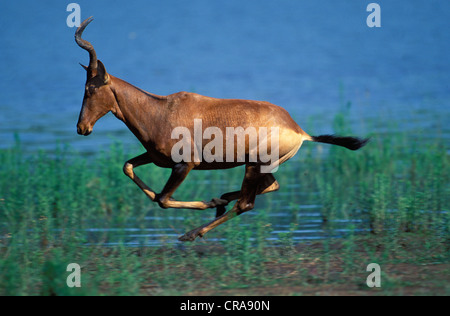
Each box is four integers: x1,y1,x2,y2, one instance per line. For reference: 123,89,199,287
0,113,450,295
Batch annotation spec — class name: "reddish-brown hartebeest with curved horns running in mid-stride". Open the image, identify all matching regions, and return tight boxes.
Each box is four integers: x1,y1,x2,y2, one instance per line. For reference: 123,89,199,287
75,17,367,241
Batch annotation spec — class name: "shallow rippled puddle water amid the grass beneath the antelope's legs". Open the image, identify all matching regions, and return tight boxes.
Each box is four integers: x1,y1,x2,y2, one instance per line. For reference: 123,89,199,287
85,205,370,247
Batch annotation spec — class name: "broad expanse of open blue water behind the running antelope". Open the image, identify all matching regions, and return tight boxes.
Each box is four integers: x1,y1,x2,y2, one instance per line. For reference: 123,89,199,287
0,0,450,152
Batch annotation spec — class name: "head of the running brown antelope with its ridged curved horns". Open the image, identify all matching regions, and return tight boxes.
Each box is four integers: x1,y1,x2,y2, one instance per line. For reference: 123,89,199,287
75,17,116,136
